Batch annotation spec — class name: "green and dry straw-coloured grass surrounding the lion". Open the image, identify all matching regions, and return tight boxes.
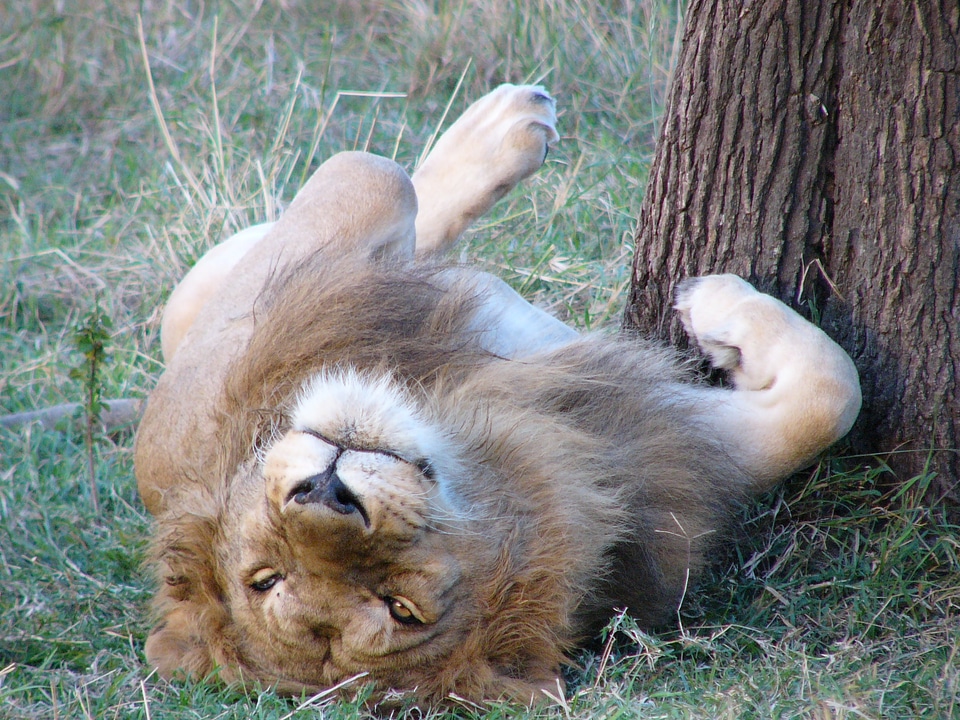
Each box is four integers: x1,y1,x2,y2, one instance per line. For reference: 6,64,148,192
0,0,960,720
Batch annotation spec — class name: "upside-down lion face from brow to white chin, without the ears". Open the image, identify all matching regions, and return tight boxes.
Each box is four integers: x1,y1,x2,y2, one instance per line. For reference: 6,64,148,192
224,375,475,685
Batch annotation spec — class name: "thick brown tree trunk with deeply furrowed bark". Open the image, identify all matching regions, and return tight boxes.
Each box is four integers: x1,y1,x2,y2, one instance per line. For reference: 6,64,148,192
624,0,960,500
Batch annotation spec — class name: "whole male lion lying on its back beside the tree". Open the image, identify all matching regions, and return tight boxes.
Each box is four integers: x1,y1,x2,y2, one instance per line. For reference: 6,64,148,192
136,85,860,703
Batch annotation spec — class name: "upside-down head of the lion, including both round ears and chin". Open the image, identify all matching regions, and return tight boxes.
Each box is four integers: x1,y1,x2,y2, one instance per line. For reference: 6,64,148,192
147,370,589,701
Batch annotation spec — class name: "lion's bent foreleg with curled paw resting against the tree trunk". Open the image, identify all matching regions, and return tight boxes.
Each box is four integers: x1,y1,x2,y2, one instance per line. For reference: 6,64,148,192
676,275,861,493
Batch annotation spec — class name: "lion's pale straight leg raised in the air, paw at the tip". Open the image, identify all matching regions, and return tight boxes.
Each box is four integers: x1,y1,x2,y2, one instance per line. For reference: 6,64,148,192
412,84,559,255
